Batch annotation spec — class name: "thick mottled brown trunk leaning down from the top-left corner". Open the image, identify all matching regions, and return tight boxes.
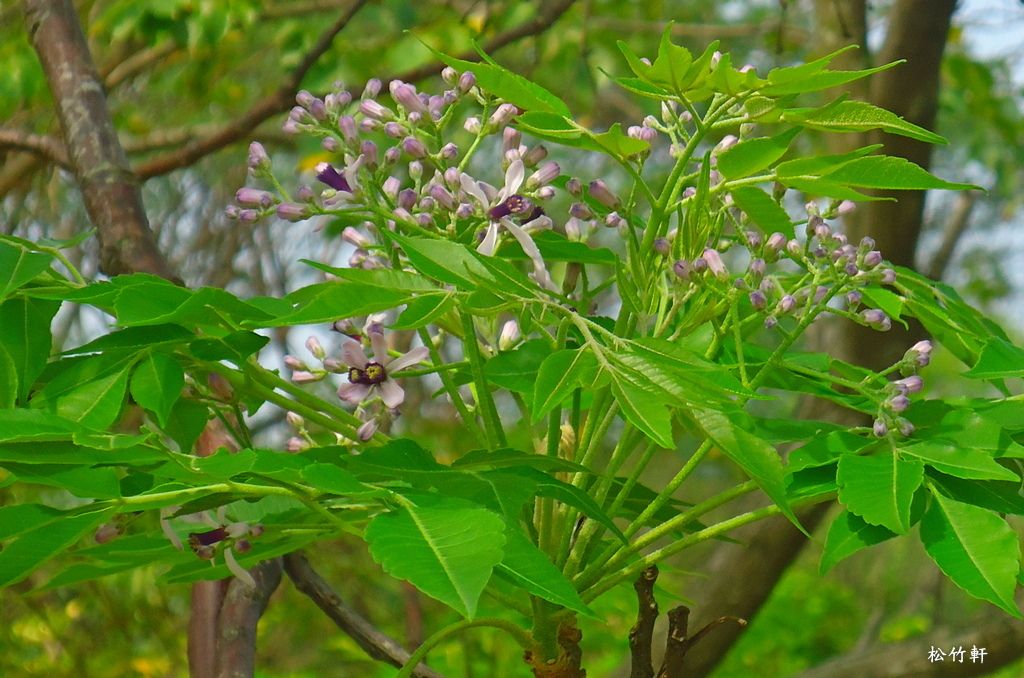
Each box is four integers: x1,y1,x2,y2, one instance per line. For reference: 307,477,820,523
25,0,180,282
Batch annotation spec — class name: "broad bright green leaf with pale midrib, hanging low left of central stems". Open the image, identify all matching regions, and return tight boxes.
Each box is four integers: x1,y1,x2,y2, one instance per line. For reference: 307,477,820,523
366,496,505,618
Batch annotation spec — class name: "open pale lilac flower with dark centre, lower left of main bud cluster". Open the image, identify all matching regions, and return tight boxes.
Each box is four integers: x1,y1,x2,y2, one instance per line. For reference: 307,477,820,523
338,332,430,408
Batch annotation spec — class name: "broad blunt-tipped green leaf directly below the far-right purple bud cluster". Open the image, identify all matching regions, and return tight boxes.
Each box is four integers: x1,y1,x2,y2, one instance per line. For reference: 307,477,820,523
837,454,925,535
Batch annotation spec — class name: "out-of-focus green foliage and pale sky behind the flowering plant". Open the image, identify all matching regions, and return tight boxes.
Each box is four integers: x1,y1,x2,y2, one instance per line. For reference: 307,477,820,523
0,0,1024,678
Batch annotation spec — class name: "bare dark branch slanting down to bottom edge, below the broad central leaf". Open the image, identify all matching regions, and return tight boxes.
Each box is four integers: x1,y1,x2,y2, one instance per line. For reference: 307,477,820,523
285,552,452,678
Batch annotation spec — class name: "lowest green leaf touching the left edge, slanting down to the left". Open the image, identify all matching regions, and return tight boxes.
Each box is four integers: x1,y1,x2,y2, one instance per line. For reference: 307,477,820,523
0,508,114,587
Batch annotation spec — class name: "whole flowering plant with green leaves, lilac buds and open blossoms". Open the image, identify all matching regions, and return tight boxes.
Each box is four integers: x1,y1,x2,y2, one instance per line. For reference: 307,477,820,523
0,19,1024,677
